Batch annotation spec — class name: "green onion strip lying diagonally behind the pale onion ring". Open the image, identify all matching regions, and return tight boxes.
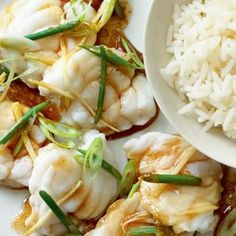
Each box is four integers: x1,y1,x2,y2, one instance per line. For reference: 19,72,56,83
74,149,122,181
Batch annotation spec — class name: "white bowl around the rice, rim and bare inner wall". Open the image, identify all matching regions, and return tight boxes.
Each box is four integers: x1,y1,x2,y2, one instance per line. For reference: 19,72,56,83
144,0,236,167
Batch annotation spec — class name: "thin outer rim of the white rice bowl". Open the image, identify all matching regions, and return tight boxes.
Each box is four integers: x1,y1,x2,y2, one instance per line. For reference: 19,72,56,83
144,0,236,168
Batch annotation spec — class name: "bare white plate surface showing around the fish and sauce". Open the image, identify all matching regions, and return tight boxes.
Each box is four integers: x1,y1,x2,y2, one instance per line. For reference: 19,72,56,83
0,0,174,236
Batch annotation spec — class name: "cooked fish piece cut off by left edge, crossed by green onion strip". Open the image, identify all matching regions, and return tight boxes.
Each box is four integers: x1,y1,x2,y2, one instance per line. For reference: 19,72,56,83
0,100,45,188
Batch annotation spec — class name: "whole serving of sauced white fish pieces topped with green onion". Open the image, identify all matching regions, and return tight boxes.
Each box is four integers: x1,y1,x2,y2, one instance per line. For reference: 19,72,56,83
0,0,236,236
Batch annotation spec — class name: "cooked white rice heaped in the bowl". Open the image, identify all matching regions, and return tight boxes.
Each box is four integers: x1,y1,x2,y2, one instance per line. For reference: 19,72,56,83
161,0,236,138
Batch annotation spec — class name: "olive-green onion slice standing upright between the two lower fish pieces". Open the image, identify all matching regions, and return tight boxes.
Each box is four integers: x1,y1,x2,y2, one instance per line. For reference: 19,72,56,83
120,160,138,197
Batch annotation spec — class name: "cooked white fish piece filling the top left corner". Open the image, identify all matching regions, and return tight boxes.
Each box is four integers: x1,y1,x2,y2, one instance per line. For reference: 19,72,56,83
0,0,96,87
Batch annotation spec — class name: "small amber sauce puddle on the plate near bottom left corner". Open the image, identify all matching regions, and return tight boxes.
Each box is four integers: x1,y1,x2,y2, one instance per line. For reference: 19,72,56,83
12,199,31,234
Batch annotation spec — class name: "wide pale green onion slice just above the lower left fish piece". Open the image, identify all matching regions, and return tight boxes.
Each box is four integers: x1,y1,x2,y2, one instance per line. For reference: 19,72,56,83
39,116,80,138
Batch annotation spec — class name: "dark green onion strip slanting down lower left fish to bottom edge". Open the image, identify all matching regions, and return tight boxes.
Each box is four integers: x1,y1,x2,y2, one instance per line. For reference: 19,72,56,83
39,191,83,236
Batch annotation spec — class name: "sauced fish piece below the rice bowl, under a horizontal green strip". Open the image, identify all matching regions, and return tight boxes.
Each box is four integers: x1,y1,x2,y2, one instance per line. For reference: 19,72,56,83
124,133,222,233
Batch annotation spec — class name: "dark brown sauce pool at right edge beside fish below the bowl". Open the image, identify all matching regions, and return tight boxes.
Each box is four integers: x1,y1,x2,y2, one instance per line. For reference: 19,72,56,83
214,167,236,236
